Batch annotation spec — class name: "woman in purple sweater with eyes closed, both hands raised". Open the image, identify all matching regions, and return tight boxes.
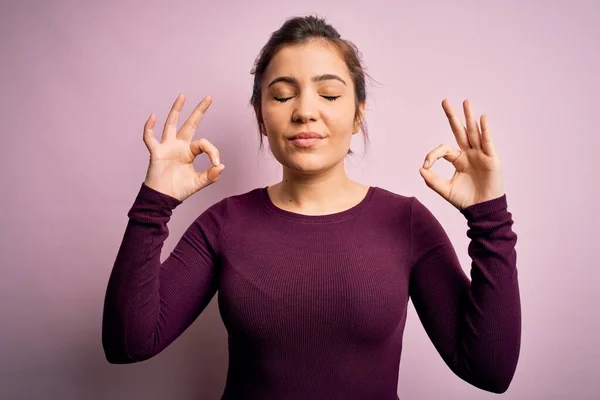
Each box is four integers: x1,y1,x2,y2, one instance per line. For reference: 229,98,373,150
103,17,521,399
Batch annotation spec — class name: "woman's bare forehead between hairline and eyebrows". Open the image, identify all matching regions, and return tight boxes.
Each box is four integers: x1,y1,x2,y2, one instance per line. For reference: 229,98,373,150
265,40,350,82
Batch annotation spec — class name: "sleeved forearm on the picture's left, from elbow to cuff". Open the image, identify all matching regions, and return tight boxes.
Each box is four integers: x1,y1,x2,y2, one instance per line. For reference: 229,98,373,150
102,184,180,363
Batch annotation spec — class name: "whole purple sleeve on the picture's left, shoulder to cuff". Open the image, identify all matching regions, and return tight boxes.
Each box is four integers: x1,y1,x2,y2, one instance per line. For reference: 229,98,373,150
102,184,226,363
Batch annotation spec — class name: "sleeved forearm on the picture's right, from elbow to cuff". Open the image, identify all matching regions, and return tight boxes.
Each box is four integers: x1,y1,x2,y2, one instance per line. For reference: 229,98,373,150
453,199,521,392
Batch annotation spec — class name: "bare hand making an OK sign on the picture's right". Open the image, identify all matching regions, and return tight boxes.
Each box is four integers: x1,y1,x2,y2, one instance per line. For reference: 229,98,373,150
419,99,504,210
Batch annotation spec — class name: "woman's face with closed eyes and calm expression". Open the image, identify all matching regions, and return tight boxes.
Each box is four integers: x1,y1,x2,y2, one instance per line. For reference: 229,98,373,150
261,41,364,173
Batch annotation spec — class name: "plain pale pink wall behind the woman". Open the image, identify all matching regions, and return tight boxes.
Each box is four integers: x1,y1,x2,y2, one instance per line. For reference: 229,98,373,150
0,0,600,400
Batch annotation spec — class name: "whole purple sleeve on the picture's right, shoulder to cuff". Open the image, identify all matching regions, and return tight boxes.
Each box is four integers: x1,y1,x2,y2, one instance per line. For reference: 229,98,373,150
409,194,521,393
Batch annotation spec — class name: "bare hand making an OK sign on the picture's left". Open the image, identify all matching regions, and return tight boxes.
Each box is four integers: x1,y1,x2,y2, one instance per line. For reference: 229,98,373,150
144,94,225,201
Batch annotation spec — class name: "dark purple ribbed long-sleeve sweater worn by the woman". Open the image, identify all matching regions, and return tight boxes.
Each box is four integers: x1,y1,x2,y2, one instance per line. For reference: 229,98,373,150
102,184,521,400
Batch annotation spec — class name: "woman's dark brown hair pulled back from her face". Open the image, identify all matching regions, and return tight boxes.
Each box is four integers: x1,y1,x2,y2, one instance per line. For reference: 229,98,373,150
250,15,368,154
